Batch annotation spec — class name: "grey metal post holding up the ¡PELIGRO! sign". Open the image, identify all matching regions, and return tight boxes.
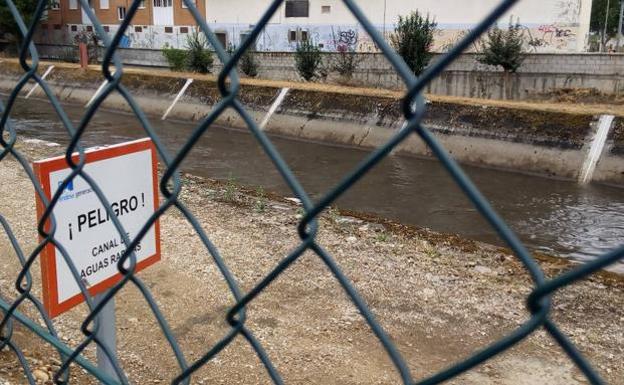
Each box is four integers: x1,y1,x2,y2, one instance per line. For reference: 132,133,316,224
93,292,119,380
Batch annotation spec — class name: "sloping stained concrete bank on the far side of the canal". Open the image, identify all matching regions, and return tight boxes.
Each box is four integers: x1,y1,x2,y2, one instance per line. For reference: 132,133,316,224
0,61,624,184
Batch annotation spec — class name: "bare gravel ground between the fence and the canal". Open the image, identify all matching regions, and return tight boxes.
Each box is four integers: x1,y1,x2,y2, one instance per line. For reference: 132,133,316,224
0,142,624,385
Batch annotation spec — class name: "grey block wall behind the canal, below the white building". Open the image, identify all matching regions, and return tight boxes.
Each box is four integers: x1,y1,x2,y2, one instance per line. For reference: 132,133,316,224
38,44,624,99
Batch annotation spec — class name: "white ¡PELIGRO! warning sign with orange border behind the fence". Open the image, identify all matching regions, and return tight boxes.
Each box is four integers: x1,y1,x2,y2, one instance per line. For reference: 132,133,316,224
34,139,160,317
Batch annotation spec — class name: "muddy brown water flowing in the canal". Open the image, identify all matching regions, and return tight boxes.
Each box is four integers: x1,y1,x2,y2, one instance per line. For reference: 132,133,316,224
6,100,624,271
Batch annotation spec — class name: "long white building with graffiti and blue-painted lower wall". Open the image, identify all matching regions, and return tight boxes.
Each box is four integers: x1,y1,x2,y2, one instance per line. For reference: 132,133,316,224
206,0,591,52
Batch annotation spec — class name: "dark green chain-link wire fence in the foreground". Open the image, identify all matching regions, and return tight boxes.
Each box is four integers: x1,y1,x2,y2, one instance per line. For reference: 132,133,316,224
0,0,624,384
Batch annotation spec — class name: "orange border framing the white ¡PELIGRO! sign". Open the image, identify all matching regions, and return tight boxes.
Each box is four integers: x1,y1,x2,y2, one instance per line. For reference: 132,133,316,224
33,138,161,318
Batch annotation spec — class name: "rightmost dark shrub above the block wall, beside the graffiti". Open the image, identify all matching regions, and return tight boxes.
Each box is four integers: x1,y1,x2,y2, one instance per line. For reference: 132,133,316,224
477,22,525,73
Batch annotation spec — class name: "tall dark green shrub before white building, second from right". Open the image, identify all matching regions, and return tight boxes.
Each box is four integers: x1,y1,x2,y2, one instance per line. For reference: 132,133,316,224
390,11,438,75
